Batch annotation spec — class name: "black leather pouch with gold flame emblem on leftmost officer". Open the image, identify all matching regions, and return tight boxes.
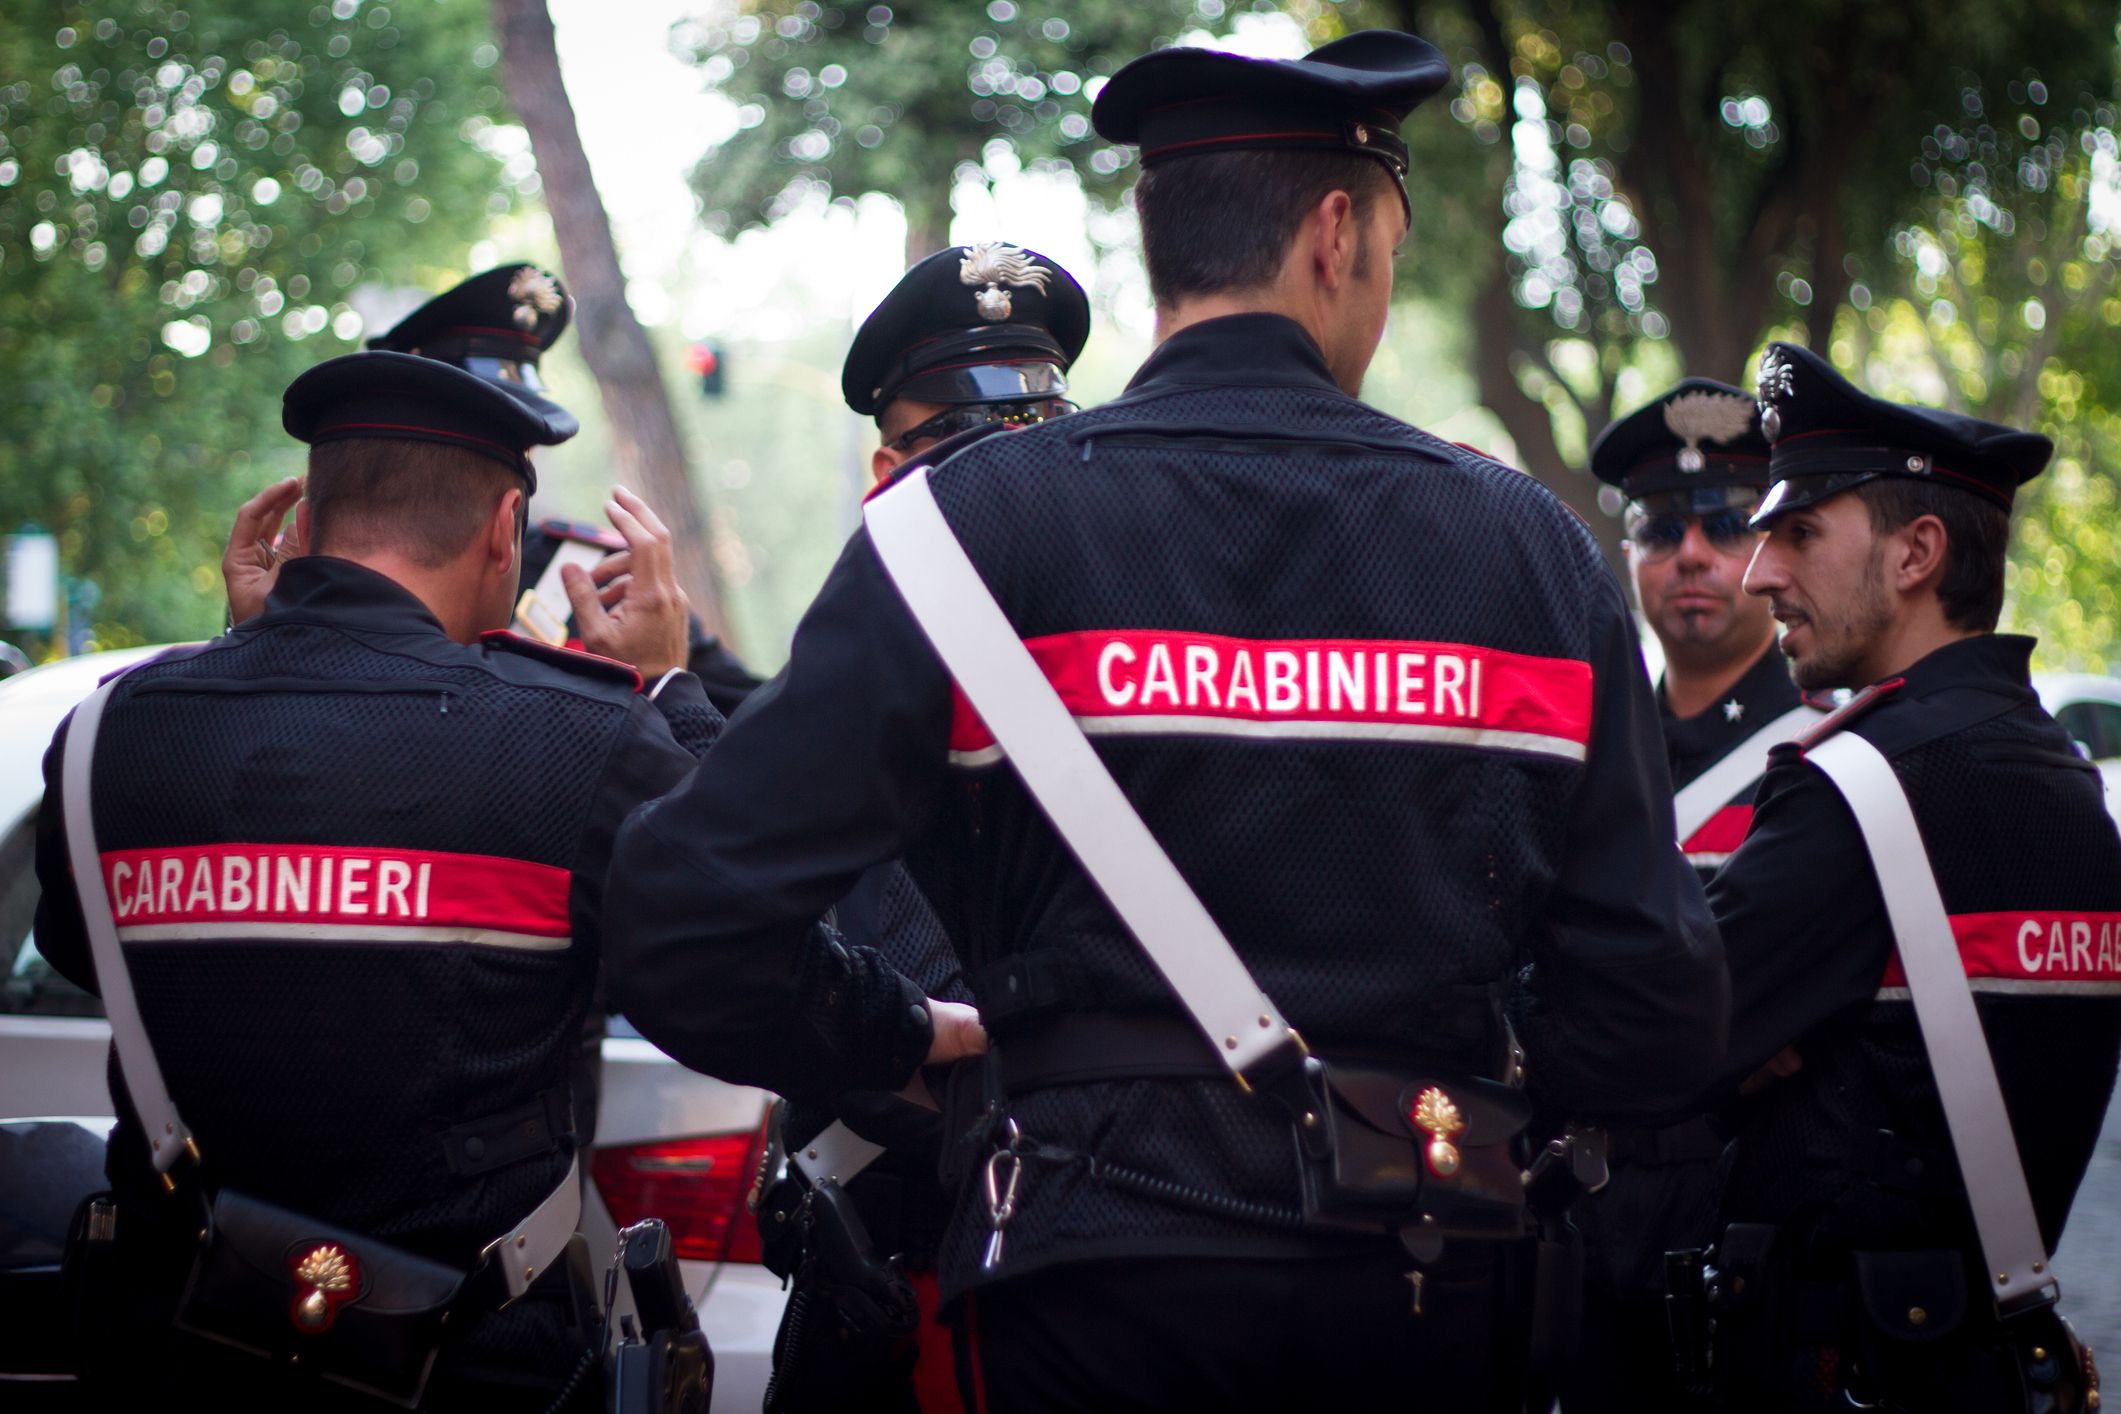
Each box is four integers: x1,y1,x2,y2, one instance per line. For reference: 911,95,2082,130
176,1189,469,1408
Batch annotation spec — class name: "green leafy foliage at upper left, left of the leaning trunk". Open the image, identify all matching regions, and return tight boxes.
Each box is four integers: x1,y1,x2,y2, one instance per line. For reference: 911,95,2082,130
0,0,517,647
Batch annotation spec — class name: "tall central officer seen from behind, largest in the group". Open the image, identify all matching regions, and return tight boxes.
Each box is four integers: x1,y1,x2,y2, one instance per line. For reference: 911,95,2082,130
613,32,1724,1410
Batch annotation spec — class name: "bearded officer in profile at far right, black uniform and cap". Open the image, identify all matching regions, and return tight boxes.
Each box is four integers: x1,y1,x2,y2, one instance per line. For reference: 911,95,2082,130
1710,343,2121,1414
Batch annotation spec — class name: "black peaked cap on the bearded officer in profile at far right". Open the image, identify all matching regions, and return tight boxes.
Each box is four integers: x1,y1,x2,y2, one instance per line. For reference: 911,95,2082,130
1752,343,2055,526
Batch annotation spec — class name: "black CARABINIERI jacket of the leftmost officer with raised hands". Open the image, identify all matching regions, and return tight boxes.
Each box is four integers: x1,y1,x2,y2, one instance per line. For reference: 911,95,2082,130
36,555,721,1369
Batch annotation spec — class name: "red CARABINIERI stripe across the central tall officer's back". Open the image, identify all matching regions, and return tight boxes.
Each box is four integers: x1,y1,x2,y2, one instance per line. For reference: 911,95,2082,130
950,630,1591,765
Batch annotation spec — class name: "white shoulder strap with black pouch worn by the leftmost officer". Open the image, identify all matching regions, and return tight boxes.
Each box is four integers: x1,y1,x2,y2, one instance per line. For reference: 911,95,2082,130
62,683,581,1408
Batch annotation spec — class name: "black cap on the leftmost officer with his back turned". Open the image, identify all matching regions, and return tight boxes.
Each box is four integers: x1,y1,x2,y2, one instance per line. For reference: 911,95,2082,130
280,352,577,492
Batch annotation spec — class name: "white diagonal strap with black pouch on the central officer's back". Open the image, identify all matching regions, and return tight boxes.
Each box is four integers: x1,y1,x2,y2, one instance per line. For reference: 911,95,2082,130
863,469,1529,1263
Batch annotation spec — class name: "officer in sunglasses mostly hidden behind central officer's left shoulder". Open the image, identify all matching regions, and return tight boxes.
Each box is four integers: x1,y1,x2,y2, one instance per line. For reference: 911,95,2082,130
759,242,1090,1414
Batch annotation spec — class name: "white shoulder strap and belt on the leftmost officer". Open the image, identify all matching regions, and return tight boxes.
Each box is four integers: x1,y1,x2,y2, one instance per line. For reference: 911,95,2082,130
59,678,581,1302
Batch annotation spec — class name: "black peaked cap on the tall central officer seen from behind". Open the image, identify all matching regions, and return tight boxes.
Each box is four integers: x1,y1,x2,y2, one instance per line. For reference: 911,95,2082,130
1090,30,1451,214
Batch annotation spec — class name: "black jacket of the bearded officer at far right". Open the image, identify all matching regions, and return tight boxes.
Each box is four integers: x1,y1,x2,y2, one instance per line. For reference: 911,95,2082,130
1710,636,2121,1259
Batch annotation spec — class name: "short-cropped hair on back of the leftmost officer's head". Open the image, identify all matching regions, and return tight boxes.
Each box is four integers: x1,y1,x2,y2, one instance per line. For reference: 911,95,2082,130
305,437,522,568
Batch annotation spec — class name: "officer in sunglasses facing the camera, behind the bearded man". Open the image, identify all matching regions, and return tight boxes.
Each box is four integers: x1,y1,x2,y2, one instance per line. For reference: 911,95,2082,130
1561,377,1822,1414
